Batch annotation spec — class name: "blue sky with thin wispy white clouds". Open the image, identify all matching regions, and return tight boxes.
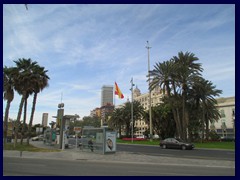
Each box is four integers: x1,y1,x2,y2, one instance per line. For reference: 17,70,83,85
3,4,235,124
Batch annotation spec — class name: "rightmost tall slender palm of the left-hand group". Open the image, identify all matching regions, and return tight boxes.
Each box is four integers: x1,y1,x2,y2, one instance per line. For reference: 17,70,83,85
27,66,50,144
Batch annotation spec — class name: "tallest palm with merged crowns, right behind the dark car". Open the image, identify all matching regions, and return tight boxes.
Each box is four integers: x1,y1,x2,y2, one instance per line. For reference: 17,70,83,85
150,52,202,140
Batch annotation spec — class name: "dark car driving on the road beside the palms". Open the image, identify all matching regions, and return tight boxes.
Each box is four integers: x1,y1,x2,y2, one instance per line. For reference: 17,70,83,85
159,138,194,150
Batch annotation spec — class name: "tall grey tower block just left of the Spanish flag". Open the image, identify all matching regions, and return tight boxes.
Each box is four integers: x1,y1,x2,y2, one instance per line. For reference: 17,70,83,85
101,85,113,107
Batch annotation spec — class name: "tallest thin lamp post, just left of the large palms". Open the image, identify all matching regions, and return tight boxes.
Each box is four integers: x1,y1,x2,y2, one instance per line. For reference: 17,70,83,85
146,41,153,141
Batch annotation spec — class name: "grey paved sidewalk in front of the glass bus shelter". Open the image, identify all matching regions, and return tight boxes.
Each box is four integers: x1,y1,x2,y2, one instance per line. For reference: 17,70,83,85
3,141,235,168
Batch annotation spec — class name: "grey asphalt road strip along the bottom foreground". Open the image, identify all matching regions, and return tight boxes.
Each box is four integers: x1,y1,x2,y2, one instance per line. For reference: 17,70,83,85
3,157,235,176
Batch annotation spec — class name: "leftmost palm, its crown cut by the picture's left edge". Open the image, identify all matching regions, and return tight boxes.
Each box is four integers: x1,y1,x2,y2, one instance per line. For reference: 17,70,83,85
3,66,14,144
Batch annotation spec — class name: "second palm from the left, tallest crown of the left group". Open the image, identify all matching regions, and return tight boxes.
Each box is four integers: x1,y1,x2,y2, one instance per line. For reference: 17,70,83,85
14,58,37,147
